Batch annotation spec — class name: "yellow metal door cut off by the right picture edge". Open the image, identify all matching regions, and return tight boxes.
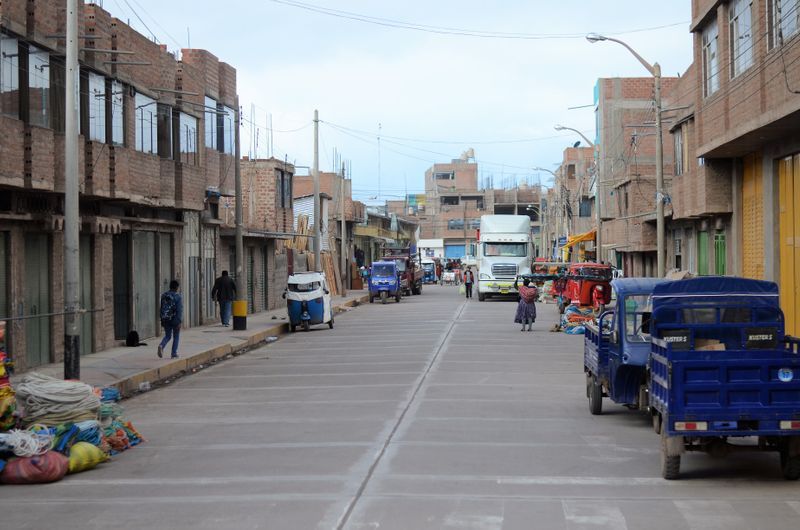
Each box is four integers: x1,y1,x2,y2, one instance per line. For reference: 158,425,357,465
778,154,800,336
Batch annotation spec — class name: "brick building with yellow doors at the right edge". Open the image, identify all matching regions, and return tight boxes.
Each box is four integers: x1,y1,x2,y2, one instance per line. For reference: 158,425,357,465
686,0,800,334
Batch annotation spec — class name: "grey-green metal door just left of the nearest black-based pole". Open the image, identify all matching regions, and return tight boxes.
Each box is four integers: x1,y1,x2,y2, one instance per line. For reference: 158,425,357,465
24,233,51,368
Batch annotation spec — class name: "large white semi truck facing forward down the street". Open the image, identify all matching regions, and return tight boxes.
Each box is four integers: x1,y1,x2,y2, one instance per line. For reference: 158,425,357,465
477,215,533,302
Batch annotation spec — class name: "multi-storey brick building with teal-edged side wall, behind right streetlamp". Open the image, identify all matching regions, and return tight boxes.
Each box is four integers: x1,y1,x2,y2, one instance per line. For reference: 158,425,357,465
595,77,678,276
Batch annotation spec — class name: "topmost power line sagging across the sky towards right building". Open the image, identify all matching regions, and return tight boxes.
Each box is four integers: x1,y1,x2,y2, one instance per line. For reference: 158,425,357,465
270,0,689,40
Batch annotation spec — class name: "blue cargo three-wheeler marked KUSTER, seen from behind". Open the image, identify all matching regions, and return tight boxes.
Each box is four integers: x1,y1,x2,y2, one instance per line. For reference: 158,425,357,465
649,277,800,480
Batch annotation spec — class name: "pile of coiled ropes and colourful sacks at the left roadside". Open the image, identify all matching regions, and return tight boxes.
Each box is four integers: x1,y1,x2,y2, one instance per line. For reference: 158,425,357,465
0,364,144,484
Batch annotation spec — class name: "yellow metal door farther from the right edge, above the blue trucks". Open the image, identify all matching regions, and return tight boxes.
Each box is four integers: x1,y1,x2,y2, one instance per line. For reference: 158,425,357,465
742,155,764,280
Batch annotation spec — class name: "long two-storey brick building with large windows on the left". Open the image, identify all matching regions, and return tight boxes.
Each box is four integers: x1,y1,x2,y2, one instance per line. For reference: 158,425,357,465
0,0,237,370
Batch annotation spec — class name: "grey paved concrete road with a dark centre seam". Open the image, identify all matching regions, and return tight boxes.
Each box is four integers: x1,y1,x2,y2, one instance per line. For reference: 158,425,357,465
0,287,800,530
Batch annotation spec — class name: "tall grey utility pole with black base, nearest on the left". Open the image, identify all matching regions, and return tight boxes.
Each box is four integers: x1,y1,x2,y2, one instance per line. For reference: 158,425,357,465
64,0,81,379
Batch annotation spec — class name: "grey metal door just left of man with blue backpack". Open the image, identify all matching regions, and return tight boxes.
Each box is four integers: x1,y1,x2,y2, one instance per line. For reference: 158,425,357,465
133,232,159,339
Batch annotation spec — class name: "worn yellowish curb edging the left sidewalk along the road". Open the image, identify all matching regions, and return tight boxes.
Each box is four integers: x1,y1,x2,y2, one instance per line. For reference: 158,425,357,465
109,295,369,398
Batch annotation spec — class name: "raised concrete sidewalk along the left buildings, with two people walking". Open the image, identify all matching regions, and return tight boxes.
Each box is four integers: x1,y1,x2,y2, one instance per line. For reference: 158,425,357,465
17,291,368,396
